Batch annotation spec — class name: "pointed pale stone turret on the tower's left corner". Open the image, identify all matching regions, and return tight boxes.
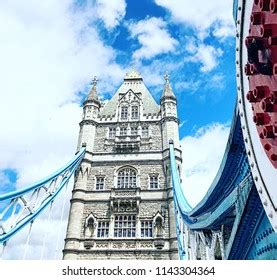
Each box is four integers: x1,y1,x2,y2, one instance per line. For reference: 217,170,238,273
78,77,101,152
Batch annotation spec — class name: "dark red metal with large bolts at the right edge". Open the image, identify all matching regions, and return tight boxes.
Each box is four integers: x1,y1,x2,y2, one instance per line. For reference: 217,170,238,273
244,0,277,168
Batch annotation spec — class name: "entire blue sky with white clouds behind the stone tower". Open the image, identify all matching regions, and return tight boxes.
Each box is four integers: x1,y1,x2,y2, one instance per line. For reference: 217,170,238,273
0,0,235,259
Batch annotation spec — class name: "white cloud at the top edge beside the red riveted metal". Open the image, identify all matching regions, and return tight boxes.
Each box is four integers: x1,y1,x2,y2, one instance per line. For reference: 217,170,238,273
155,0,234,38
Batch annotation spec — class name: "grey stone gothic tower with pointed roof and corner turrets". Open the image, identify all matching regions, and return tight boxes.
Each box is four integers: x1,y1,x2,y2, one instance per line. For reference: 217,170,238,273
63,70,181,260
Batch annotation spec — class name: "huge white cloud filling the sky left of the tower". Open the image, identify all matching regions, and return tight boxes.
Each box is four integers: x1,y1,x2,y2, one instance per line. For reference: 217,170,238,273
0,0,123,258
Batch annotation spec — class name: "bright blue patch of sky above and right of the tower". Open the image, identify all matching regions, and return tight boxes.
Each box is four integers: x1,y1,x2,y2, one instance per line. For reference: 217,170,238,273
91,0,235,138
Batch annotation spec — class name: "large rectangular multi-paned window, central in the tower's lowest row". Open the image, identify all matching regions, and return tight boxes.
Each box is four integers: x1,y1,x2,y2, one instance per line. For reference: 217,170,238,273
114,215,136,237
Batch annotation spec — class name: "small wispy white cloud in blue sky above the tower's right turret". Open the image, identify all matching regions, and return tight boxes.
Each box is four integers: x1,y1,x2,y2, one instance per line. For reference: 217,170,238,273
185,40,223,72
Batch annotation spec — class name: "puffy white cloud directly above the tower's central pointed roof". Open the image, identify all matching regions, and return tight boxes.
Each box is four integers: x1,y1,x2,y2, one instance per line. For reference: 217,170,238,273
128,17,178,60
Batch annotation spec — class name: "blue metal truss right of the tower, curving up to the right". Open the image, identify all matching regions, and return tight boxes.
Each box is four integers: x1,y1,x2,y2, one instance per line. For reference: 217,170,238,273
170,106,277,259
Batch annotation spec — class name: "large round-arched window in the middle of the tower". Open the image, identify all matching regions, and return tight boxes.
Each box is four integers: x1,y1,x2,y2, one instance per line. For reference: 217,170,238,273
116,166,138,190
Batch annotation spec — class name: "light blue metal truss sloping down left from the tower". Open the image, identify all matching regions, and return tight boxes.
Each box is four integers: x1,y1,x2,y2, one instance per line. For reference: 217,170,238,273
0,148,85,243
